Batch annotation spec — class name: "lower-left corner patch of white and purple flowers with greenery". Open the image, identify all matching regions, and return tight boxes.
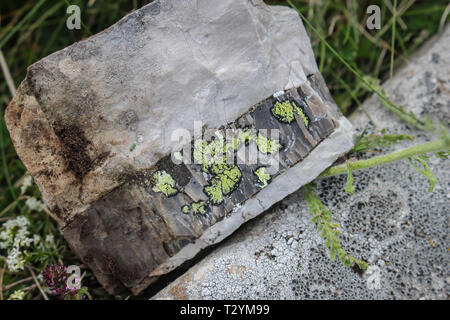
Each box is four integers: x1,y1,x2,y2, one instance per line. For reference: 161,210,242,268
0,168,111,300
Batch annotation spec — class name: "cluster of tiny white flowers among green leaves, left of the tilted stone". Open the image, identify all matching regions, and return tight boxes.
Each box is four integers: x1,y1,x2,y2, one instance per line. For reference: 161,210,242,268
0,175,66,300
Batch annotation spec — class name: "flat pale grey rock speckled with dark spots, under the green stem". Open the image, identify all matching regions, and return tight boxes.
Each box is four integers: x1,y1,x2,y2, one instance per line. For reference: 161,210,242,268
154,27,450,299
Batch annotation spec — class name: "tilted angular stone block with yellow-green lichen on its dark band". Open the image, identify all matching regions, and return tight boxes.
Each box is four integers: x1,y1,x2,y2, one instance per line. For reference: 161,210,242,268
5,0,353,293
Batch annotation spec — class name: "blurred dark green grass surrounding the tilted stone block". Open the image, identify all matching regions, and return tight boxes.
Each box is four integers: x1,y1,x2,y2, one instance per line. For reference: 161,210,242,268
0,0,450,299
